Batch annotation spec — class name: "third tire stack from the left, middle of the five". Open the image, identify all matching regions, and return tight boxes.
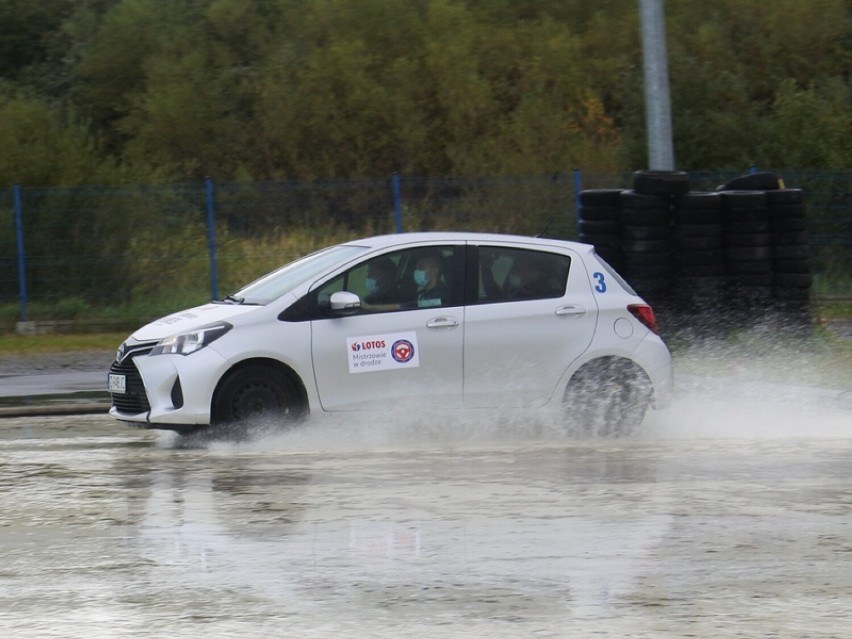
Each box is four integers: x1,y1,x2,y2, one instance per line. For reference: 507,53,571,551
672,191,728,331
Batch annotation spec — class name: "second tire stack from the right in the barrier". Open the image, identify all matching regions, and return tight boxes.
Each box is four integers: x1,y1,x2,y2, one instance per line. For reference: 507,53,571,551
721,191,774,325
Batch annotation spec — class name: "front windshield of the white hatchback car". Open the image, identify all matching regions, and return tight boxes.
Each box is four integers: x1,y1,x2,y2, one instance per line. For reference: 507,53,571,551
224,245,367,306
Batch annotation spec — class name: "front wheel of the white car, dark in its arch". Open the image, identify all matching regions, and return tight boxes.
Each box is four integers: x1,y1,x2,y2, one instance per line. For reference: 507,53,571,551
212,363,306,425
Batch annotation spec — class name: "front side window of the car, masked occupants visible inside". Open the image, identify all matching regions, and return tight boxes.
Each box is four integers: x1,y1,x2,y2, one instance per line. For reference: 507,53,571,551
312,246,460,317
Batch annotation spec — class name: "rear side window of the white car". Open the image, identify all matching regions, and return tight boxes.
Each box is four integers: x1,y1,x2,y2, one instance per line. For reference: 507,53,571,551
475,246,571,304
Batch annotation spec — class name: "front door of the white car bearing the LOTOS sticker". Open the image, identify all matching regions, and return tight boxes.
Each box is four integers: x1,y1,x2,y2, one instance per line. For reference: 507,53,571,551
311,246,464,414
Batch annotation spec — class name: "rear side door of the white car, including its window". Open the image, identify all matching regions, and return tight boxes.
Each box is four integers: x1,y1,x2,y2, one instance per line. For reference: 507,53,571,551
464,243,597,407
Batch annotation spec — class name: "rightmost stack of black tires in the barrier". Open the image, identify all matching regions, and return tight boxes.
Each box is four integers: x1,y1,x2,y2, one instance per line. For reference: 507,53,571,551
766,189,813,330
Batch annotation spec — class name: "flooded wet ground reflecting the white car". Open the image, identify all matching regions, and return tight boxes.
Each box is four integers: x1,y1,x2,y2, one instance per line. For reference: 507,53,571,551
0,406,852,639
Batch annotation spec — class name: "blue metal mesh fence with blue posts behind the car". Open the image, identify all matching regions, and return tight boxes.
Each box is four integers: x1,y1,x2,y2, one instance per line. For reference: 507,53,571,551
0,169,852,320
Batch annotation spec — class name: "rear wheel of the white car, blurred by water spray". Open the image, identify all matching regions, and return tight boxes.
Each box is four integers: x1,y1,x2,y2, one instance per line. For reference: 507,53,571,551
562,357,653,437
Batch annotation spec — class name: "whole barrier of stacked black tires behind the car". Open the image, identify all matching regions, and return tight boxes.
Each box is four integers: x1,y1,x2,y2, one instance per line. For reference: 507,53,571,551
578,171,813,336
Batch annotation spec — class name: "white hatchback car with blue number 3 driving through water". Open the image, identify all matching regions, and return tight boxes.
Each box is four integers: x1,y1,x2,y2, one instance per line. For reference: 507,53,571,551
108,232,672,435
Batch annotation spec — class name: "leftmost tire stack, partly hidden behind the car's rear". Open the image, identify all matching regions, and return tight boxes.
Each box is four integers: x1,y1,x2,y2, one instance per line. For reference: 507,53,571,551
578,189,624,272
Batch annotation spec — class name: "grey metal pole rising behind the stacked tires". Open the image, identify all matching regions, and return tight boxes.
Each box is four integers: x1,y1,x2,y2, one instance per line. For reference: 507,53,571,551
639,0,675,171
